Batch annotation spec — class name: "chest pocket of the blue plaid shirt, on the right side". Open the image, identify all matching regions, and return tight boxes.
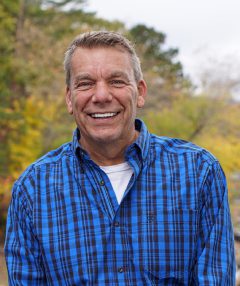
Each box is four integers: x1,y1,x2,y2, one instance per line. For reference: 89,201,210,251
129,208,198,285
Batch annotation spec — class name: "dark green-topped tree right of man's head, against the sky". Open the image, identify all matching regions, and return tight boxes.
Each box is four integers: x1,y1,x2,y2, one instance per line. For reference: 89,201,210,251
129,25,191,110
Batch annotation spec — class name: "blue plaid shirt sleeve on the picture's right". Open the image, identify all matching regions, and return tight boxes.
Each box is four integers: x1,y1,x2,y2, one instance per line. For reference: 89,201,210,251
194,162,235,286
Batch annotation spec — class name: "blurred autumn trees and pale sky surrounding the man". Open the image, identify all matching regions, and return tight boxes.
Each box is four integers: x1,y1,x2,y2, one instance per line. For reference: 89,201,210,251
0,0,240,286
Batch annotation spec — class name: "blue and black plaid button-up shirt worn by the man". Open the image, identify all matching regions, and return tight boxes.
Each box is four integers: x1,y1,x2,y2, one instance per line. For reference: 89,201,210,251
5,120,235,286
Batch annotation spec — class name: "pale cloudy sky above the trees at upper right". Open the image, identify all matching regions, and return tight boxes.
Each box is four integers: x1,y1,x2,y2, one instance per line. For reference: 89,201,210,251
85,0,240,89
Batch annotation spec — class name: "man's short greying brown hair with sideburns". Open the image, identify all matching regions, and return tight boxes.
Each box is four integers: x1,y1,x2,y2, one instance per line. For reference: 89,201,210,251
64,31,143,86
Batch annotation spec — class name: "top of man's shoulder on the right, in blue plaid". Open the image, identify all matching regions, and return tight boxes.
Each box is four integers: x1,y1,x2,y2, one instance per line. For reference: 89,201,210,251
151,134,217,162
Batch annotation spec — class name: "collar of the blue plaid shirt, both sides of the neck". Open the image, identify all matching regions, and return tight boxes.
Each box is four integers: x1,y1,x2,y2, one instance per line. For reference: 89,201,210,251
72,119,150,161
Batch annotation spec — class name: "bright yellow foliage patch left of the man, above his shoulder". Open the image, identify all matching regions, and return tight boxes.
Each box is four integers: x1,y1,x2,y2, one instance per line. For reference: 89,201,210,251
7,97,44,178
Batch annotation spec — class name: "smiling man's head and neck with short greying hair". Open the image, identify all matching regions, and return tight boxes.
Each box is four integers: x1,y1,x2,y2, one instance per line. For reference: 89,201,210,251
65,32,146,163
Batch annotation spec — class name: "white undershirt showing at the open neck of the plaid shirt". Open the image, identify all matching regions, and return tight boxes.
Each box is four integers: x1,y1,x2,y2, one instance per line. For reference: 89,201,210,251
100,162,133,204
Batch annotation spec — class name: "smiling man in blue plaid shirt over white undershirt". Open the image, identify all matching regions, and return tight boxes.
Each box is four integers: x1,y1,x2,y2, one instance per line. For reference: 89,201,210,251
5,32,235,286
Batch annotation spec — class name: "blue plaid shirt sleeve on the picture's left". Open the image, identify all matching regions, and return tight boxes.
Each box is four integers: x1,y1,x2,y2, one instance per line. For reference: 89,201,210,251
4,186,47,285
